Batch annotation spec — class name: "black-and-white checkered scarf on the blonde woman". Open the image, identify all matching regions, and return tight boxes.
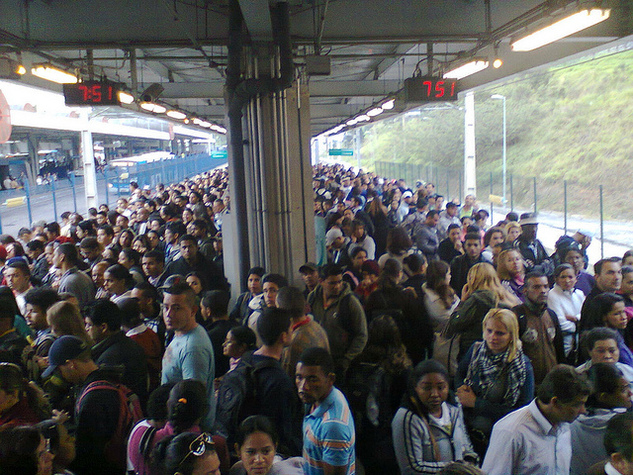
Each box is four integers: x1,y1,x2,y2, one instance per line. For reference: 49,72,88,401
464,342,527,407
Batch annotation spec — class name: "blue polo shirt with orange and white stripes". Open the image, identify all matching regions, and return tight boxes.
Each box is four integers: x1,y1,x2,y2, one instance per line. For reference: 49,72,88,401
303,387,356,475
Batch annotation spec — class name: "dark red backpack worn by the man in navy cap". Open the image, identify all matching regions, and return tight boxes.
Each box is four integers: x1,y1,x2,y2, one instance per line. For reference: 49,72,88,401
76,380,143,467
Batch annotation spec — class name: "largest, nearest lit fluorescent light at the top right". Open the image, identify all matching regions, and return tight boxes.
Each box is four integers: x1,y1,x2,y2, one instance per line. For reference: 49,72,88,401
511,8,611,51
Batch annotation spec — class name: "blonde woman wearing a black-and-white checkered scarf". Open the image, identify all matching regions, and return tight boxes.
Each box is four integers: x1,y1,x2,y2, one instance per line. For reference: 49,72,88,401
455,308,534,455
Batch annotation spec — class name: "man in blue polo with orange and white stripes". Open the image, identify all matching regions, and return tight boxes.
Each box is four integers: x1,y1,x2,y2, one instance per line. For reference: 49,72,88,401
295,347,356,475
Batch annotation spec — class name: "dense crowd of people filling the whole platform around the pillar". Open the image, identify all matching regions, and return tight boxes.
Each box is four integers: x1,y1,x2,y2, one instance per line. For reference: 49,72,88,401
0,165,633,475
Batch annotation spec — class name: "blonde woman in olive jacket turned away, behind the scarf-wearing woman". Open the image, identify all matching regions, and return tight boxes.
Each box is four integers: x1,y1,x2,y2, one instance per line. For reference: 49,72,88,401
446,262,521,360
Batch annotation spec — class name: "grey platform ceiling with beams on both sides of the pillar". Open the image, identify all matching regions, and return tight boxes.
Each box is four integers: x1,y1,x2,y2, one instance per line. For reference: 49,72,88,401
0,0,633,135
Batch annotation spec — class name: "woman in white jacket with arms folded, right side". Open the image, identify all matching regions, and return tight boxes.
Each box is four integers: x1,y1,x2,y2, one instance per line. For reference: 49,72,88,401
547,264,585,356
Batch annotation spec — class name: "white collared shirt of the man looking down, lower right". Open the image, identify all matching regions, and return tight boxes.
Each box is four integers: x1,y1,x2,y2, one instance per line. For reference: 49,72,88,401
482,399,571,475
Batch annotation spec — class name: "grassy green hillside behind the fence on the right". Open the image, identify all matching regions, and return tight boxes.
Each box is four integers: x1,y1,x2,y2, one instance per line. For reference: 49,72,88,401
361,47,633,219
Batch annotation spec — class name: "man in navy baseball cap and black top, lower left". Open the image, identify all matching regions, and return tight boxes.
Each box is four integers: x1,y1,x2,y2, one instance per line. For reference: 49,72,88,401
42,335,139,475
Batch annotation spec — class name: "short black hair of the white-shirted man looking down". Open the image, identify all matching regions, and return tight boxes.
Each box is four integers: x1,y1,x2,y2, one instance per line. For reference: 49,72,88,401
536,364,591,404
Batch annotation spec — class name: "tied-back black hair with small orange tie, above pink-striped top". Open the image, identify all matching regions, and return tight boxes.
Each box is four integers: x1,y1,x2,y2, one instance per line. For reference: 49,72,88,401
167,379,209,434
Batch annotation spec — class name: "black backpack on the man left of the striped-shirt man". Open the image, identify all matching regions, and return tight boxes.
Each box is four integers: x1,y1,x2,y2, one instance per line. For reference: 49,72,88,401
216,353,276,446
